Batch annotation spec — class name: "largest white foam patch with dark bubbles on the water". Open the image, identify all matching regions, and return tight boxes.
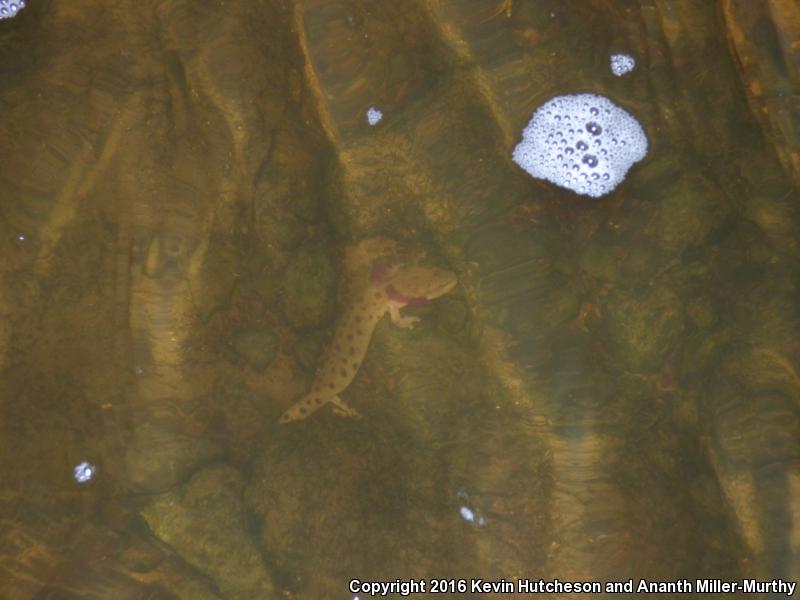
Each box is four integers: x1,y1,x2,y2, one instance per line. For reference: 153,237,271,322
511,94,647,198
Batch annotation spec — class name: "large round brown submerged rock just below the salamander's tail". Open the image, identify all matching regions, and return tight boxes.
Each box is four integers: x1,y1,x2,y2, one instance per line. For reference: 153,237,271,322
245,414,418,598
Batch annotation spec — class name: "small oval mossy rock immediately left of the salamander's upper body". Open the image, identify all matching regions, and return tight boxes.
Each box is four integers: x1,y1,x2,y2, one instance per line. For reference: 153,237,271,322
283,244,336,328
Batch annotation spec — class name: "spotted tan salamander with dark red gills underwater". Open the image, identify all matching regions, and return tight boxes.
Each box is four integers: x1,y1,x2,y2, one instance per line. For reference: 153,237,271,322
280,264,458,423
